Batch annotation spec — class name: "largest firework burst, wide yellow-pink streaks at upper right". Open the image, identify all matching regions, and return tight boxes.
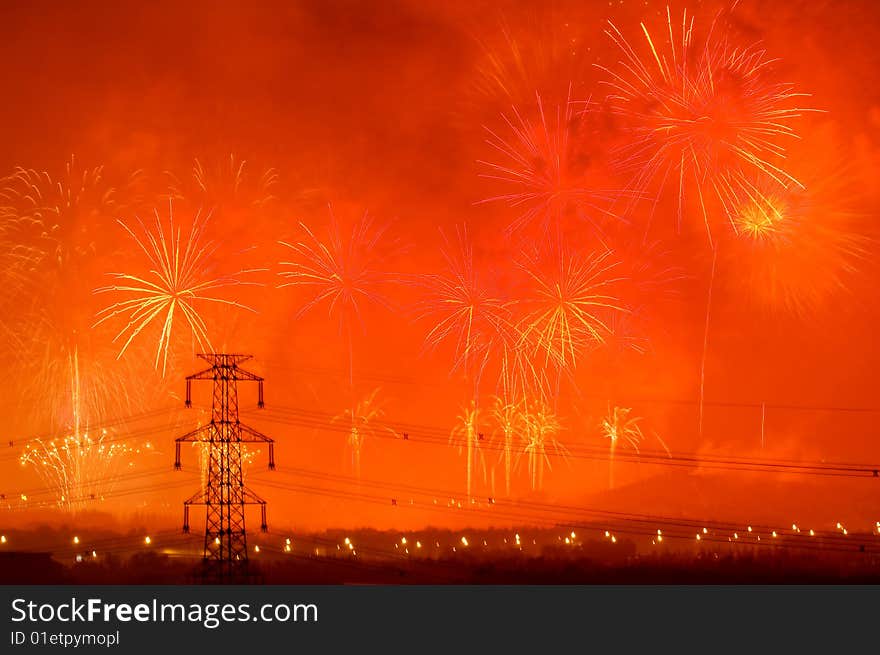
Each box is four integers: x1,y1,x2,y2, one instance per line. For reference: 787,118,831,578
599,7,815,243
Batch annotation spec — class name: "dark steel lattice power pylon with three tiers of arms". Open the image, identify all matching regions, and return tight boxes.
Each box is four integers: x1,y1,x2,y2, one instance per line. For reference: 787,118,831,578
174,353,275,579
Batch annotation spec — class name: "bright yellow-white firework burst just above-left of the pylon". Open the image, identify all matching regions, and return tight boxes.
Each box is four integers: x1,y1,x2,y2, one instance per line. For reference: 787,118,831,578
94,201,258,376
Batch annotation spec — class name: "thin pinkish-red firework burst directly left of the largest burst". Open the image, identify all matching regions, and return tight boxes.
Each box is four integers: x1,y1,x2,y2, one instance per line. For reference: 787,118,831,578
478,90,620,235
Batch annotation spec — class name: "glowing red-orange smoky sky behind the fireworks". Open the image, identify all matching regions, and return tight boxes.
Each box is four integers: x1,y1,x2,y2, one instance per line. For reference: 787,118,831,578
0,0,880,527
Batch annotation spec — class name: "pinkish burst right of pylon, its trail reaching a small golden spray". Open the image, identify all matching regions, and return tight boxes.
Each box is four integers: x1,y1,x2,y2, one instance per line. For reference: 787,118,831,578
278,206,397,476
